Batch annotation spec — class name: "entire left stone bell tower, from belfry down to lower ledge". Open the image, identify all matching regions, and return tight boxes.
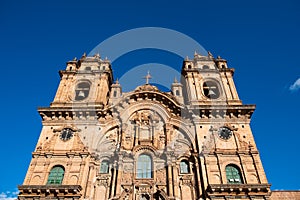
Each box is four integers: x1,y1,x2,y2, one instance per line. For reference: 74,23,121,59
18,54,113,199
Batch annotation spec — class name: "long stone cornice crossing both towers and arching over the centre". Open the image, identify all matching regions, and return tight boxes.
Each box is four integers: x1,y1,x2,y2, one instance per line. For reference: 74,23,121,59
38,104,255,122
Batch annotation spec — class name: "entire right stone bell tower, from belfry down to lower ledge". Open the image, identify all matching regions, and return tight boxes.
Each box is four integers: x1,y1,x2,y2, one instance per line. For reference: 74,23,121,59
181,52,270,199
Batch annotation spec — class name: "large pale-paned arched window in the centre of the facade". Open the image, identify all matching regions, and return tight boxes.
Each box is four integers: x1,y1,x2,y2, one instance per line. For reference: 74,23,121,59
136,154,152,178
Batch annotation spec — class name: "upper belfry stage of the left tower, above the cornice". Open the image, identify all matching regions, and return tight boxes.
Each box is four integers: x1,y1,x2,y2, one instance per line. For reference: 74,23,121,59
51,53,113,107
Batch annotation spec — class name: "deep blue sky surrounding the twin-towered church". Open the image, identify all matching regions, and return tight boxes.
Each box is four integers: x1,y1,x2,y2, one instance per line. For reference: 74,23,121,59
0,0,300,199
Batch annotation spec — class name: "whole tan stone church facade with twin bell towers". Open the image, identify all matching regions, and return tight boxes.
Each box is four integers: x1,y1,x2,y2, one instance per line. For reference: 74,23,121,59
18,53,298,200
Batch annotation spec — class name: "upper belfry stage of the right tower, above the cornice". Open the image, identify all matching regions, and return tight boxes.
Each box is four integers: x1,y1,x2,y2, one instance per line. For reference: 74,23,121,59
181,52,241,105
